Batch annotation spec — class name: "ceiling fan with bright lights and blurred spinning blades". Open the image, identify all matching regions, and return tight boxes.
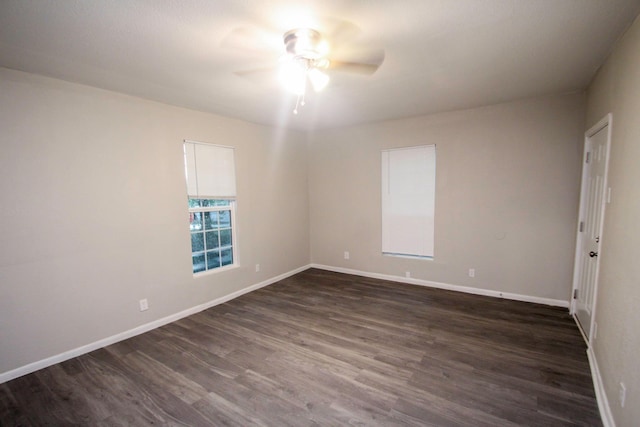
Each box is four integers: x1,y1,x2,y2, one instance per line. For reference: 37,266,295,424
228,21,385,114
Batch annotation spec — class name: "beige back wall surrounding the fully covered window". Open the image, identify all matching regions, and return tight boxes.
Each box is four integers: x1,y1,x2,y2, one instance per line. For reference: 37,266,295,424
309,94,584,302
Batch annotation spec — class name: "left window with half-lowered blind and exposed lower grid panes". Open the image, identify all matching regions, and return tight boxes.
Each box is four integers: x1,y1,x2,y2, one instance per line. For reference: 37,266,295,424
184,141,237,274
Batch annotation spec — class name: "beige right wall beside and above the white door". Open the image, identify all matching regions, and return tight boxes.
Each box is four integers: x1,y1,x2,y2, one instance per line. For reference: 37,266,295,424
587,14,640,427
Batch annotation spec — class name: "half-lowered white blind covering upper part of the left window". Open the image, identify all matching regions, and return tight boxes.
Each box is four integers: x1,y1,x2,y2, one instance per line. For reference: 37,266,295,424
184,141,236,199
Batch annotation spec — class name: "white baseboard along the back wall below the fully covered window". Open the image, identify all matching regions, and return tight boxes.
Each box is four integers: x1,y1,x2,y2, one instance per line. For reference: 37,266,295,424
311,264,569,309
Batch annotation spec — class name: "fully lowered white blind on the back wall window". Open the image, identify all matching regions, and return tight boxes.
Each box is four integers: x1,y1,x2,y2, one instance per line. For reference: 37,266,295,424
382,145,436,258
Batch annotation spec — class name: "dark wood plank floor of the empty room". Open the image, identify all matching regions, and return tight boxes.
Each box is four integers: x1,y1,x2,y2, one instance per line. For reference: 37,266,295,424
0,269,601,427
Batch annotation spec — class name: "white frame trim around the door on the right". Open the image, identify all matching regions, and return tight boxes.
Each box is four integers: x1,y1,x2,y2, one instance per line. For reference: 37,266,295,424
569,113,613,346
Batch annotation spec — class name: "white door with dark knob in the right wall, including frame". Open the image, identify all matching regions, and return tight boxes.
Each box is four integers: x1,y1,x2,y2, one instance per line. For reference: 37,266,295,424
572,115,611,342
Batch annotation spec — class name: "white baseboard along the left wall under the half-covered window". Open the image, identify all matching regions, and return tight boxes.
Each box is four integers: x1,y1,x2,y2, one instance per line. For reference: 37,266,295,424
0,265,311,384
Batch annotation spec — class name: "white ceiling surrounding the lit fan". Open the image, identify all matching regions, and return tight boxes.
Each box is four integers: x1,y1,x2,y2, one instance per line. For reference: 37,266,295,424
0,0,640,129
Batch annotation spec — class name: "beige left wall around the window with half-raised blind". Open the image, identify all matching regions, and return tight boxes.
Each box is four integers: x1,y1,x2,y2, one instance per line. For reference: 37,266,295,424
0,69,309,374
